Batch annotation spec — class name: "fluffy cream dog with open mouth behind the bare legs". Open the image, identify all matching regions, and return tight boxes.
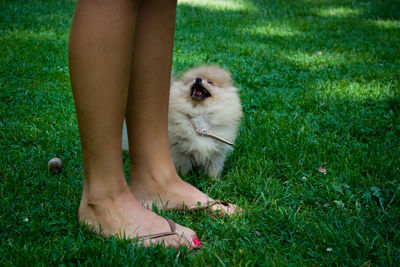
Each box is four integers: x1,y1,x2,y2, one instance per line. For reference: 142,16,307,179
123,66,242,177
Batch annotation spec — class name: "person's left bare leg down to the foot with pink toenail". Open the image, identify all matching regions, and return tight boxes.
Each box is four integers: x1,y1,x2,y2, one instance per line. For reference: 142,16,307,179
69,0,196,249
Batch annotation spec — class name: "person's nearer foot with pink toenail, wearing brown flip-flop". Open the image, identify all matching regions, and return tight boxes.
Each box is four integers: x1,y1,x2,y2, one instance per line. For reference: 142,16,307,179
79,190,199,248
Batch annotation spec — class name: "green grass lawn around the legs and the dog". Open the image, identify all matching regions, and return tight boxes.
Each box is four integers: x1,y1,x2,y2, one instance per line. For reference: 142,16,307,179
0,0,400,266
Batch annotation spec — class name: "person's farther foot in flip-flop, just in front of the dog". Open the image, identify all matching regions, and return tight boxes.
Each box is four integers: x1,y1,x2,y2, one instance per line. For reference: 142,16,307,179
129,170,242,218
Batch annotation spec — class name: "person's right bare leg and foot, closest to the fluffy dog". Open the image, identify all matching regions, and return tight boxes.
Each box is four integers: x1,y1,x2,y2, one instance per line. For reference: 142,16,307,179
126,0,233,213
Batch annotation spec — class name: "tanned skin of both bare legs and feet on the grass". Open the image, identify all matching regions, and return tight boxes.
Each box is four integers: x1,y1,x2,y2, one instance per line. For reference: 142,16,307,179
69,0,238,247
